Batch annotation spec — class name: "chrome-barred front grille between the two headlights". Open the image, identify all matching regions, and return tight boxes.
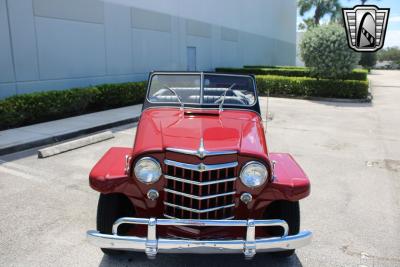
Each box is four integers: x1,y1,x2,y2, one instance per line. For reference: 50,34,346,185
164,160,237,219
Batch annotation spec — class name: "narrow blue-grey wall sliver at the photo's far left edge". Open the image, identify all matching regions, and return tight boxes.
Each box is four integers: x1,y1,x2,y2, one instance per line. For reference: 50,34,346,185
0,0,15,83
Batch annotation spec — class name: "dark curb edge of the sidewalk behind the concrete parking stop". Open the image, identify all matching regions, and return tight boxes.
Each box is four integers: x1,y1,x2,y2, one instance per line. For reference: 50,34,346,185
0,116,140,156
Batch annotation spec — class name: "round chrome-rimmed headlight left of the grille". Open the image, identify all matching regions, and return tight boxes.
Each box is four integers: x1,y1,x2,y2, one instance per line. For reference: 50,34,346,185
134,157,161,184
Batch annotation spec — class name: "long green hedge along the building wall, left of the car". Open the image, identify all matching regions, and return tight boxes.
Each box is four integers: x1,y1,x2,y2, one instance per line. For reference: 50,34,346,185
0,82,146,130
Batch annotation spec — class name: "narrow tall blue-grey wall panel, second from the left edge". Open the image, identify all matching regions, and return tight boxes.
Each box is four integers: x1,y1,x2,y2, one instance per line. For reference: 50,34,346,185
7,0,39,81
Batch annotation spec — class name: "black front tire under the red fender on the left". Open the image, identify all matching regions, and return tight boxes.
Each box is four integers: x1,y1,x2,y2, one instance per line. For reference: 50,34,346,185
97,194,135,256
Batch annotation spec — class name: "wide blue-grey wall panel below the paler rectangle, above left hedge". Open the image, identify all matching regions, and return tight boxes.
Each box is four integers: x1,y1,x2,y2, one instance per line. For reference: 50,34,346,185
36,17,106,80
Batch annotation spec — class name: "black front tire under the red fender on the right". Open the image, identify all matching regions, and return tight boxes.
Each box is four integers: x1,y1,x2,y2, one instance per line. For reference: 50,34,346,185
264,200,300,257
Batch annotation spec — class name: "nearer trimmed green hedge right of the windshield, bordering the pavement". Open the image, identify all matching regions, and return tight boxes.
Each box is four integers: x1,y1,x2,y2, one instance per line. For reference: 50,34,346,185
256,75,368,99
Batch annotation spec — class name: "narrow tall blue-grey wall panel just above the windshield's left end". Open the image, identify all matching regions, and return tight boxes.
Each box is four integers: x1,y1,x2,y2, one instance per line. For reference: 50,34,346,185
104,3,133,75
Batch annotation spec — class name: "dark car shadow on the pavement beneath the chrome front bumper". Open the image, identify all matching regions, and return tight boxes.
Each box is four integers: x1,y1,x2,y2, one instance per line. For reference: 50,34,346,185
99,253,303,267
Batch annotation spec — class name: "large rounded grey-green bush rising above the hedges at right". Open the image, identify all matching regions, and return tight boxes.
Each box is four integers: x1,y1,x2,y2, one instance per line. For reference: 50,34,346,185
300,24,360,79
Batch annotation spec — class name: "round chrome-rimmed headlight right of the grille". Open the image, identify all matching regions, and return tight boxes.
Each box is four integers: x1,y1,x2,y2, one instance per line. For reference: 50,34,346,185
240,161,268,187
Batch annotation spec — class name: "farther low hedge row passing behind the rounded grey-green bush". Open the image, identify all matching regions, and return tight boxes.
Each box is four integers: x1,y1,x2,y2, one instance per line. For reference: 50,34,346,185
215,66,368,81
